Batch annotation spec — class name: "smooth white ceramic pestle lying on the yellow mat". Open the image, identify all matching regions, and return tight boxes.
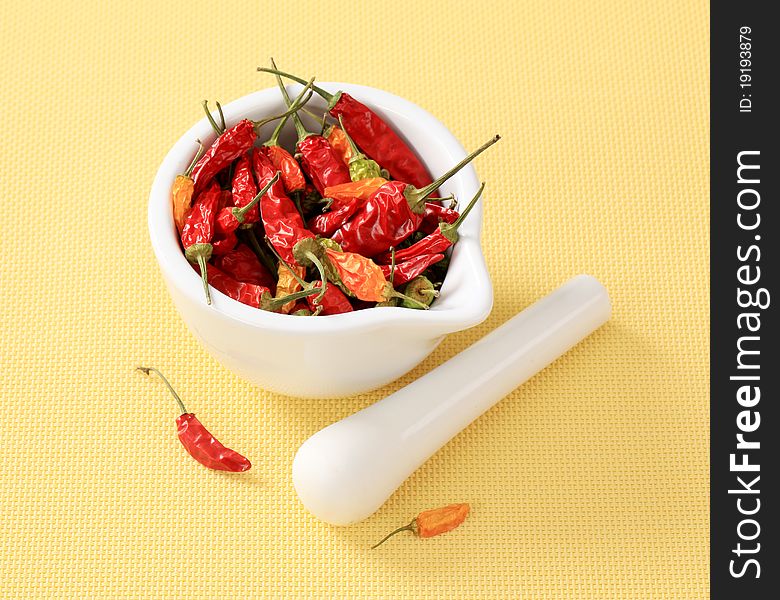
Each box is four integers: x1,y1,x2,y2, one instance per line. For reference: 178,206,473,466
293,275,611,525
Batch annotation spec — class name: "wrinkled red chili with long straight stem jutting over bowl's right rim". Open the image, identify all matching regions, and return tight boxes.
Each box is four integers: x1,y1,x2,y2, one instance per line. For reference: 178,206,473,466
332,136,501,257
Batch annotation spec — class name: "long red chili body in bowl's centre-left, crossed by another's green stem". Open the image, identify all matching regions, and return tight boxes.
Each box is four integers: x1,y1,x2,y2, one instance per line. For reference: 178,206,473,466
252,152,314,262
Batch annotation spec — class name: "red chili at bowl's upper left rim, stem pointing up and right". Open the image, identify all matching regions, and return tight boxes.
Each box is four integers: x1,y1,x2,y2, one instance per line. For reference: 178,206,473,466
192,89,310,193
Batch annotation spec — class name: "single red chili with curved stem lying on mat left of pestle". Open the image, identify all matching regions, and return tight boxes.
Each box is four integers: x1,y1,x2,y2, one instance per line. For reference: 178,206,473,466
138,367,252,473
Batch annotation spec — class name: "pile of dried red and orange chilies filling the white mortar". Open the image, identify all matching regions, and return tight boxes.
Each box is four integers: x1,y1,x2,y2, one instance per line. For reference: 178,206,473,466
172,61,500,316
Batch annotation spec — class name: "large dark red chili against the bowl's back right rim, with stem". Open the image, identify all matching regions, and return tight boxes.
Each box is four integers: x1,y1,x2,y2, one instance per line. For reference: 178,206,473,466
258,67,435,189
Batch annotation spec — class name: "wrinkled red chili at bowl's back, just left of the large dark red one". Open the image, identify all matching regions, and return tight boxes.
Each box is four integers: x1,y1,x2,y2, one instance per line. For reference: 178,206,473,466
277,59,352,194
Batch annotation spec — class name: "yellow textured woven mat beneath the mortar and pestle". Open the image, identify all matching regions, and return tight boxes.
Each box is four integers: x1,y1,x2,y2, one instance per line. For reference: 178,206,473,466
0,0,709,599
